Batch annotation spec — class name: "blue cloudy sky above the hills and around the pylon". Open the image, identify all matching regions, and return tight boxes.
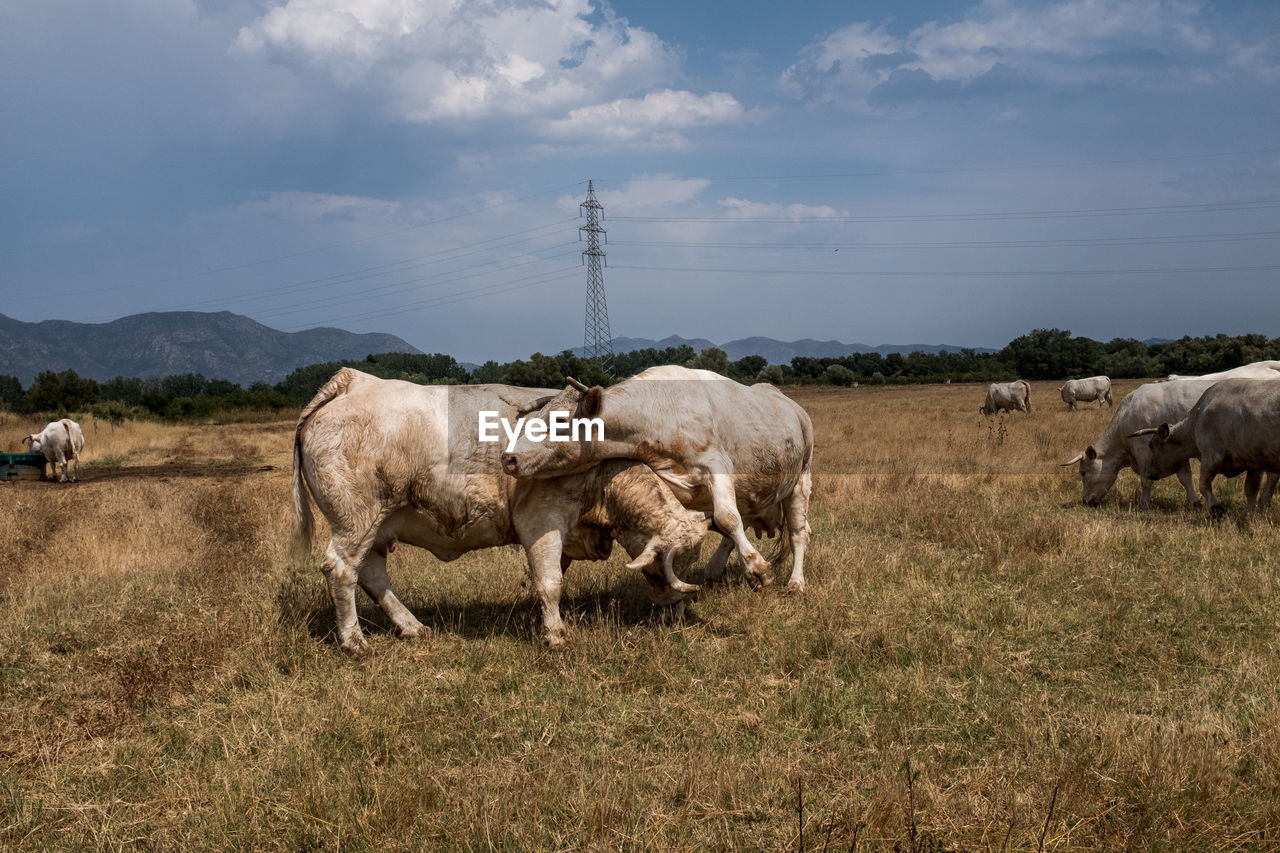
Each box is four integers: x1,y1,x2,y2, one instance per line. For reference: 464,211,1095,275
0,0,1280,361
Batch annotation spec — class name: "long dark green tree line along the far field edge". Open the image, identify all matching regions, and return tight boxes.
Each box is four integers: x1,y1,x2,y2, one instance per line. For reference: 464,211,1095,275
0,329,1280,421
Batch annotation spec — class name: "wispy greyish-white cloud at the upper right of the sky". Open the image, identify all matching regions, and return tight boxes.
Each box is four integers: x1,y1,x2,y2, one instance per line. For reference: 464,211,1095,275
782,0,1215,109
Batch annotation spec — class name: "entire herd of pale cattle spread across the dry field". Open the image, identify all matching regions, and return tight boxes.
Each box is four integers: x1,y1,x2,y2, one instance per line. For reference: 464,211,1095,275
23,361,1280,645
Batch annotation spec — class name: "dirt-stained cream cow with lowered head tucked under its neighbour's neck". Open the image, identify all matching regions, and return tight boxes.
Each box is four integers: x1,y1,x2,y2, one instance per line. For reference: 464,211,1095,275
293,368,710,653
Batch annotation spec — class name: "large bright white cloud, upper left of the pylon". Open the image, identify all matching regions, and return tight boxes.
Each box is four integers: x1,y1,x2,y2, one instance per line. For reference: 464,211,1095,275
236,0,742,135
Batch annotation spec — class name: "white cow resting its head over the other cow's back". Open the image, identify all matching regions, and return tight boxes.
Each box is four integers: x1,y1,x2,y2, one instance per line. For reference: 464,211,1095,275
502,365,813,592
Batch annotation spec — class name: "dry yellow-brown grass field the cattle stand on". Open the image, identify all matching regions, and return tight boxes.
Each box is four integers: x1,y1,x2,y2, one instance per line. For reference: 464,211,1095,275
0,383,1280,850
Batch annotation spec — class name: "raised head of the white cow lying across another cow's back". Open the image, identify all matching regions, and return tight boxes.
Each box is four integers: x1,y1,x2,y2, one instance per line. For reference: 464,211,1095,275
502,377,604,478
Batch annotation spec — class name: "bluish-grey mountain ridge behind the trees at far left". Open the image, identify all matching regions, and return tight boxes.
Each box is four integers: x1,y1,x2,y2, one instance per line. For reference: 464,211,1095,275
0,311,420,387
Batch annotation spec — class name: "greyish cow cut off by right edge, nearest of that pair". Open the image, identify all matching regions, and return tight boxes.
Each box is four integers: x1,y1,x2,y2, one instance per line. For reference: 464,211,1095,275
1133,379,1280,516
